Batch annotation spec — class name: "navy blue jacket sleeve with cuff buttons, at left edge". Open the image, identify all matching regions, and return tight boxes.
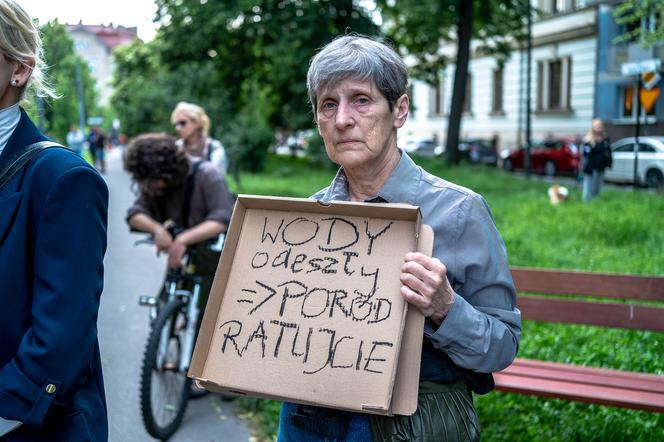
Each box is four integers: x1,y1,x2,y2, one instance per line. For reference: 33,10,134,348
0,166,108,427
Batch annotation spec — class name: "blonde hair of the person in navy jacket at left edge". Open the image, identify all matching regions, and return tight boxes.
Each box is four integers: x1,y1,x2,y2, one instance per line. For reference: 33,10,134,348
0,0,57,98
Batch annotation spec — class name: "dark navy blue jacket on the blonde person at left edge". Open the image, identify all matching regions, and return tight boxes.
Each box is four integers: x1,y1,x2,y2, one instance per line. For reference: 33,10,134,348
0,110,108,442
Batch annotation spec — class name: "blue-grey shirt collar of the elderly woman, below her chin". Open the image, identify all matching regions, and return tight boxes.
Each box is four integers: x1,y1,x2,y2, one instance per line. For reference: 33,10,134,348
327,151,422,205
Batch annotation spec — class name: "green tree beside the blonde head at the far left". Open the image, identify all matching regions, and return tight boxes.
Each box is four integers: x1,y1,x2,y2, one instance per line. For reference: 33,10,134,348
26,21,99,142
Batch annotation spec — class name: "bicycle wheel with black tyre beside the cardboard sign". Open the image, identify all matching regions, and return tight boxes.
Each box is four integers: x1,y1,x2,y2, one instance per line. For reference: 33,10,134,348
141,299,191,440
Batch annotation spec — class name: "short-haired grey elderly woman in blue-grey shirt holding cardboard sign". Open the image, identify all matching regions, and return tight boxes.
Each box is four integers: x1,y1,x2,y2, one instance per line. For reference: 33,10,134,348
279,36,521,442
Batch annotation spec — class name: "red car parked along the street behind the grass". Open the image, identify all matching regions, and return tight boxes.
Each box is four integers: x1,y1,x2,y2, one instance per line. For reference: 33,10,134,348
501,139,580,176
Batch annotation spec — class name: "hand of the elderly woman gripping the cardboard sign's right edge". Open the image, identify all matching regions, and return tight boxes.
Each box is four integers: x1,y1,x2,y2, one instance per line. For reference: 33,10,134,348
400,252,454,325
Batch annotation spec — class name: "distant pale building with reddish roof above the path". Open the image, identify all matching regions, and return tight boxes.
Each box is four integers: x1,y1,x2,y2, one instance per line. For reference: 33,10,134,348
67,23,138,106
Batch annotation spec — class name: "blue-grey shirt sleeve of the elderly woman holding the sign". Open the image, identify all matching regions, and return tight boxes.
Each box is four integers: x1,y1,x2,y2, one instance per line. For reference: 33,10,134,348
425,194,521,373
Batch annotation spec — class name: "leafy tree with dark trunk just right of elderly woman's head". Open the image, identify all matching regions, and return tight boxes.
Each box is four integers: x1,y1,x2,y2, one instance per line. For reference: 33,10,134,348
376,0,529,164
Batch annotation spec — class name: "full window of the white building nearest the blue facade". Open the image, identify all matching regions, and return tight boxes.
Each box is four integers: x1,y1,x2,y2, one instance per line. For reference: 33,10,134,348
537,57,572,112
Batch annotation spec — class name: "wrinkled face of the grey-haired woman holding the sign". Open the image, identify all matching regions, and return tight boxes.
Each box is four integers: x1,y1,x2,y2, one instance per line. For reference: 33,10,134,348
316,79,408,169
